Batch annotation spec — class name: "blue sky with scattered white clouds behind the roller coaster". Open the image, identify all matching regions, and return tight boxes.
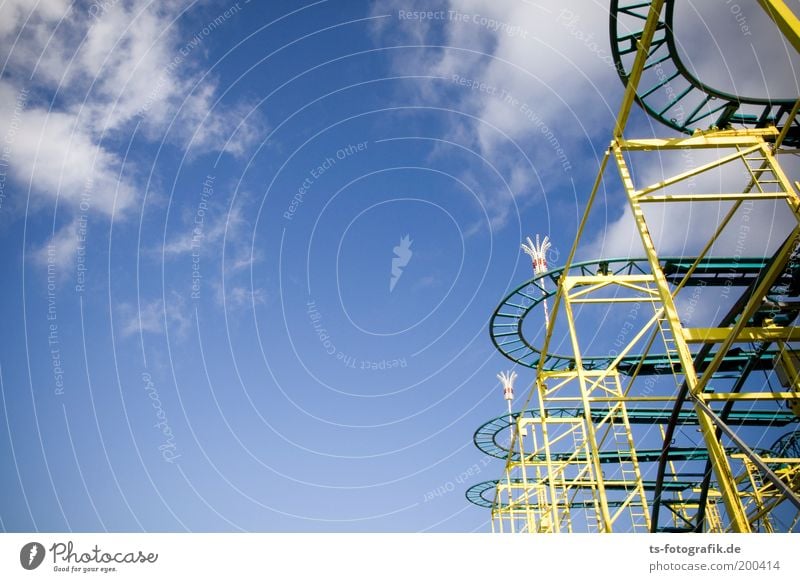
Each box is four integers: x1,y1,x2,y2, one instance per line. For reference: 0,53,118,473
0,0,797,531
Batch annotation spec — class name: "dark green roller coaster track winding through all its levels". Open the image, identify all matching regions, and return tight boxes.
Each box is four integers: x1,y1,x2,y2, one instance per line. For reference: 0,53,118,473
466,0,800,532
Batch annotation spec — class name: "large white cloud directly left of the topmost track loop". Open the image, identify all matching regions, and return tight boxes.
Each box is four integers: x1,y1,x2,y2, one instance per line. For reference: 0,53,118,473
373,0,621,232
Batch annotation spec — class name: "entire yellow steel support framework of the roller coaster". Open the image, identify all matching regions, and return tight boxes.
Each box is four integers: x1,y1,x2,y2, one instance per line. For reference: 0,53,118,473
468,0,800,533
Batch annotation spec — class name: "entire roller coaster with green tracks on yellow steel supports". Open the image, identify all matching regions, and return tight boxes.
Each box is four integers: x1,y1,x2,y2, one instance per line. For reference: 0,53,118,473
466,0,800,533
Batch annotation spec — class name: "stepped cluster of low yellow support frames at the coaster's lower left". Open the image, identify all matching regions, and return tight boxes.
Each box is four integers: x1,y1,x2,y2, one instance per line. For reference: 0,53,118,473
492,360,663,533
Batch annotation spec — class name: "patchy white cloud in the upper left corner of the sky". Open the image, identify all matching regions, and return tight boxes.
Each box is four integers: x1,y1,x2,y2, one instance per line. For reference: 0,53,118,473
0,0,264,230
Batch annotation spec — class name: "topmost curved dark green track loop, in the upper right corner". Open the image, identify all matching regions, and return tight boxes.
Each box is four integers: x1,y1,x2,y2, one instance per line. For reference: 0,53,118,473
610,0,800,147
